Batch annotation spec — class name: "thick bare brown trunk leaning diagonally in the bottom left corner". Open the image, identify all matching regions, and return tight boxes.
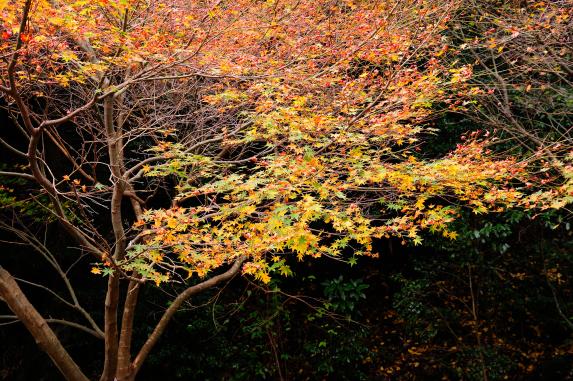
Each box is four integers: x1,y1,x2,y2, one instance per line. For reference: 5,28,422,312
0,267,89,381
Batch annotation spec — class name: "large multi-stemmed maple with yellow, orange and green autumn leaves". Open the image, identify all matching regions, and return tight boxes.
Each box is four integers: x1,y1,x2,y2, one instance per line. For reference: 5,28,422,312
0,0,570,380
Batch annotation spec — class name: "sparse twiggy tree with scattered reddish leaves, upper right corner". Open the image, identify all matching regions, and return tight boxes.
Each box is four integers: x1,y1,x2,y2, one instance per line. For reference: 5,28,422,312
451,1,573,176
